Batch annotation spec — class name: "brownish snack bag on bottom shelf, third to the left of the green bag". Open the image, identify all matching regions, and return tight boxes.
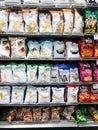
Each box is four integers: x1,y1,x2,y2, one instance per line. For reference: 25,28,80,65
41,107,50,121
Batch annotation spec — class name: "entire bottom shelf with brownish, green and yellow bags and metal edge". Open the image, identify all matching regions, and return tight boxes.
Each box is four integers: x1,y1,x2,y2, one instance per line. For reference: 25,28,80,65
0,106,98,128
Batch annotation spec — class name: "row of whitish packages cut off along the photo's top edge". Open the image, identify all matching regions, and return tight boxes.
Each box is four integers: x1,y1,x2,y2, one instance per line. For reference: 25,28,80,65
0,0,98,9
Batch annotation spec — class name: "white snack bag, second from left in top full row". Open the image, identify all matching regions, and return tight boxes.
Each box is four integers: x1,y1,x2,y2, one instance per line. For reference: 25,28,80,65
8,12,24,32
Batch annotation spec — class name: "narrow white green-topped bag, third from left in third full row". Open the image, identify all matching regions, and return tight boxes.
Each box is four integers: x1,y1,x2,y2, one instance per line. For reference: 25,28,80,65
27,65,37,83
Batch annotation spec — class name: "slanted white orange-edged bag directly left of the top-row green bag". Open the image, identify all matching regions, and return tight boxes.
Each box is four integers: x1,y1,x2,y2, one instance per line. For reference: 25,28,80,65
72,9,83,33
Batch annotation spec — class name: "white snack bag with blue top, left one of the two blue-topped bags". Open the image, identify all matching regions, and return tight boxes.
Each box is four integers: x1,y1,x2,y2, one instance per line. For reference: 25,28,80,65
58,64,70,83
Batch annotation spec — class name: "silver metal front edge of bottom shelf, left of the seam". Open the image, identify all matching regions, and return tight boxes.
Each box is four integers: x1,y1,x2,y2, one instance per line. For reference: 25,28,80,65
0,120,77,128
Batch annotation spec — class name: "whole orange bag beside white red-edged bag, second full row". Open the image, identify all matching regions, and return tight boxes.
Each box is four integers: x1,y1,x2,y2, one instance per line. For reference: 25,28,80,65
80,38,94,58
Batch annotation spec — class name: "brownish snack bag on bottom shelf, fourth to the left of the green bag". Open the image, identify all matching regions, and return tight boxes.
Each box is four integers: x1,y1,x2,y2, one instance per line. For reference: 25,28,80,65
33,107,42,122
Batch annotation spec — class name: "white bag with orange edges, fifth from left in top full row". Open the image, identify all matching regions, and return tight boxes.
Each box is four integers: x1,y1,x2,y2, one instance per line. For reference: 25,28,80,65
50,11,64,33
